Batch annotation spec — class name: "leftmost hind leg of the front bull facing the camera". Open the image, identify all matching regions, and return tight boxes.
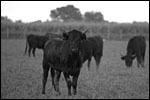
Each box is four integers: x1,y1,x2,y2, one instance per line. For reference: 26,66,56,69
42,61,50,94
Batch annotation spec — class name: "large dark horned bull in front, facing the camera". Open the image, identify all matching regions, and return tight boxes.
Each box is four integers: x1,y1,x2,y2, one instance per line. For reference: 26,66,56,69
42,30,86,95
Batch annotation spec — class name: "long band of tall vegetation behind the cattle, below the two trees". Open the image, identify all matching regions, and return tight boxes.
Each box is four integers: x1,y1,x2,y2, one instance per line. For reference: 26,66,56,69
1,17,149,39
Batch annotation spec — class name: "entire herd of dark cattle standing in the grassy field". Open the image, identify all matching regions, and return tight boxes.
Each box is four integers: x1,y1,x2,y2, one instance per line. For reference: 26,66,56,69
24,30,146,95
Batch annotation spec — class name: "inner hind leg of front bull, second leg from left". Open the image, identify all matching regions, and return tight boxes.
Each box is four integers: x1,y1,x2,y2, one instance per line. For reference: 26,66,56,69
54,70,61,95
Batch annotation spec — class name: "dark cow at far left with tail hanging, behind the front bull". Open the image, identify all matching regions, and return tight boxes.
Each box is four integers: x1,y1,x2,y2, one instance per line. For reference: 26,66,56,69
24,34,49,57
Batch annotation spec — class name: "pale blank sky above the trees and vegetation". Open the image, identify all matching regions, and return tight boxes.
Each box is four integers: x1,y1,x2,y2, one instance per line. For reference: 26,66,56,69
1,1,149,23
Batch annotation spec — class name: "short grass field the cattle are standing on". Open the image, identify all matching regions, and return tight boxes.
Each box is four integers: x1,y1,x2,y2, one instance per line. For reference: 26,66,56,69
1,40,149,99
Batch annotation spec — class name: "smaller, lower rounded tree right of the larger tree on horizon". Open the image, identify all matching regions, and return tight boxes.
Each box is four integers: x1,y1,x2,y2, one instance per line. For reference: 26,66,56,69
84,11,104,22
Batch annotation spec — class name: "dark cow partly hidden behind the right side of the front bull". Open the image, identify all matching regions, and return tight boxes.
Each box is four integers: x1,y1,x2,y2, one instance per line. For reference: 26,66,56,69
81,36,103,70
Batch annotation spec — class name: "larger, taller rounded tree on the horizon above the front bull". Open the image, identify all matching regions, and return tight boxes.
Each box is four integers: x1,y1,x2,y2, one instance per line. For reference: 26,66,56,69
50,5,83,21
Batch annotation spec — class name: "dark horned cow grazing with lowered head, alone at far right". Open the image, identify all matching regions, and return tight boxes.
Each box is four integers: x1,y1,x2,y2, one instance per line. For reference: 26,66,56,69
121,36,146,67
